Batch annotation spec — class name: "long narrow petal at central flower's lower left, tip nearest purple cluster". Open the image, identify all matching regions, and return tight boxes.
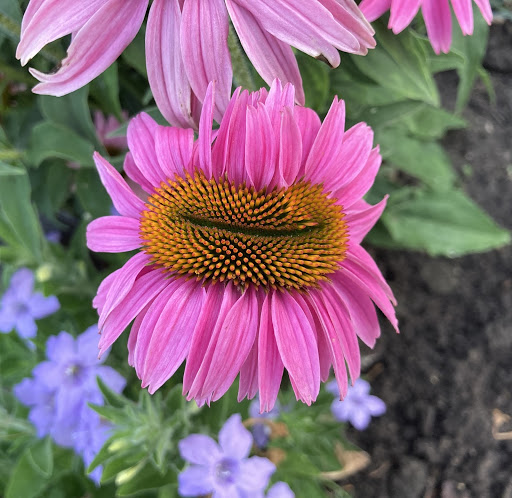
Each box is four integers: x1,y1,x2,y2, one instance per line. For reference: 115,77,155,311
99,269,170,355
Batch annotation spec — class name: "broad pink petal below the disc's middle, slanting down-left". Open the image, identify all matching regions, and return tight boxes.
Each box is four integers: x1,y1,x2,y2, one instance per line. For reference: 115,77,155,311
204,287,259,401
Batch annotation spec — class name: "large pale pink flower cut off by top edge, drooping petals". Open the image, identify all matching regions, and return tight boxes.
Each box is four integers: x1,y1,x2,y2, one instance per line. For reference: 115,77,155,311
16,0,375,128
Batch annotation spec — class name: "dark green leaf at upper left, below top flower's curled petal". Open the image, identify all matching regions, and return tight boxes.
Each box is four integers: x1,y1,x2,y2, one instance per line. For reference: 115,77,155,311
27,121,94,166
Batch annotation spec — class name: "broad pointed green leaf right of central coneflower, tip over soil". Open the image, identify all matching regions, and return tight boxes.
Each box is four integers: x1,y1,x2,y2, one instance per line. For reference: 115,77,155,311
381,190,510,257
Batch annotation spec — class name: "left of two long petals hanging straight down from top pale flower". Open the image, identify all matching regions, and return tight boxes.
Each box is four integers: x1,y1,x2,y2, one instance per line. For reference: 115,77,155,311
146,0,196,128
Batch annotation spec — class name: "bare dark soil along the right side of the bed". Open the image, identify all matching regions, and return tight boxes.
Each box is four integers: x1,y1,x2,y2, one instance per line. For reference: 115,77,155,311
347,24,512,498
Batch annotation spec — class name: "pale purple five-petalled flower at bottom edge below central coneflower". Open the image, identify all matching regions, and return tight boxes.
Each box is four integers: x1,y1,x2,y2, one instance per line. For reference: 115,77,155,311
178,414,279,498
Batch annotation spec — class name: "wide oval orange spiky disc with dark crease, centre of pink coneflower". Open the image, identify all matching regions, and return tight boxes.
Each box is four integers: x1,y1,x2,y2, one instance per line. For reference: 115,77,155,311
140,171,348,290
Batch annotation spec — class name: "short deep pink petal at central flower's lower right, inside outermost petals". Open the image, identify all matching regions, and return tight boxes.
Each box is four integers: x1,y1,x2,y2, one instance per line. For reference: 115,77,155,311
331,271,380,348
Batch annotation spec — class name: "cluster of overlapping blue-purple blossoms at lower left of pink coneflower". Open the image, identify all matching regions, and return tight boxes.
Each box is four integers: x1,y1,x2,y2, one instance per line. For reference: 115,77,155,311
14,325,126,480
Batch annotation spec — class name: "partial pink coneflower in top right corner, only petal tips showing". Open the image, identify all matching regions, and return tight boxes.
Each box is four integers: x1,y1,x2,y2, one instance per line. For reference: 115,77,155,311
359,0,492,54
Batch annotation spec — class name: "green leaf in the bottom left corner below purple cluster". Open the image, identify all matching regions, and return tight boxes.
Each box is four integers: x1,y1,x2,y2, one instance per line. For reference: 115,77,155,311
5,438,53,498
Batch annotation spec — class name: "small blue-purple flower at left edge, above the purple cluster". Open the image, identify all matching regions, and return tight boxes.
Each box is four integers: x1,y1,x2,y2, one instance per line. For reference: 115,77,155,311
0,268,60,339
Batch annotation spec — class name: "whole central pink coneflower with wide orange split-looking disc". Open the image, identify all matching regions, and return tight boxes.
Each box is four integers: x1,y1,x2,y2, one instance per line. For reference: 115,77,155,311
87,80,398,411
